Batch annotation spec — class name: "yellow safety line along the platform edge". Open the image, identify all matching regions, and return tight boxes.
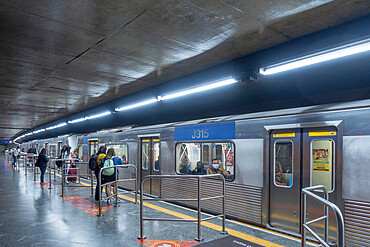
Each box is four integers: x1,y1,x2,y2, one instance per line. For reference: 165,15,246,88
44,174,299,247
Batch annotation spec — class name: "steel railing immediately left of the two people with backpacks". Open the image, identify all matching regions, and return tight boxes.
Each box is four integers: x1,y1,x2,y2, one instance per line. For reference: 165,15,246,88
60,159,94,197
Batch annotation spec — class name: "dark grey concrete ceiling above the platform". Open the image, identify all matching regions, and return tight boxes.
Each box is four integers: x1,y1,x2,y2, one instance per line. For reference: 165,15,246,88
0,0,370,138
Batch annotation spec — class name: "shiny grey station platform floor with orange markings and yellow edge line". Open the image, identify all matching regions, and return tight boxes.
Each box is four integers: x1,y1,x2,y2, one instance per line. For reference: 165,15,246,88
0,155,312,247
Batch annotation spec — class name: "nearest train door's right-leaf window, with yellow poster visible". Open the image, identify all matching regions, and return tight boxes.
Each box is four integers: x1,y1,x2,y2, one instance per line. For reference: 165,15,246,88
311,140,334,192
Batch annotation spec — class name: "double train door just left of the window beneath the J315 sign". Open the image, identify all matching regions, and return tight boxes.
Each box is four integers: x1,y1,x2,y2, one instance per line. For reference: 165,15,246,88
140,137,161,196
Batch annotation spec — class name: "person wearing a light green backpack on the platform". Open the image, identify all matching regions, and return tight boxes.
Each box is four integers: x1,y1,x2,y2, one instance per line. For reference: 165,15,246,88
101,148,123,203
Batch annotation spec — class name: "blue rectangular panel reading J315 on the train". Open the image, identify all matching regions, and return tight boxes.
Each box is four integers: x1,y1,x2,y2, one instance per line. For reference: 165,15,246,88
175,122,235,141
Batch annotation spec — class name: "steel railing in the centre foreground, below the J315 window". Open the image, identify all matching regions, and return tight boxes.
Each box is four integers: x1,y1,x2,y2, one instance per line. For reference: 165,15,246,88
138,174,227,241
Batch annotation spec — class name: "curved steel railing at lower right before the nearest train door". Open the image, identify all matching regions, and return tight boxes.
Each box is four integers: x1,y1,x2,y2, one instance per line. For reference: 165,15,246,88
301,185,344,247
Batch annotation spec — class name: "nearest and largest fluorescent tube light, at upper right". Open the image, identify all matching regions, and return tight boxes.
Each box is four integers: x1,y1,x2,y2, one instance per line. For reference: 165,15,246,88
259,39,370,75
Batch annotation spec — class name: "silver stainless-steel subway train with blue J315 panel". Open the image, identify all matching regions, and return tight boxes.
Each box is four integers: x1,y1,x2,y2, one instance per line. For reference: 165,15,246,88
22,100,370,246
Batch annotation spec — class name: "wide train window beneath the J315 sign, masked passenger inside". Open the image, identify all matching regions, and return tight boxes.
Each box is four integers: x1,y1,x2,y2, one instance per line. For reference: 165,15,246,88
176,142,234,180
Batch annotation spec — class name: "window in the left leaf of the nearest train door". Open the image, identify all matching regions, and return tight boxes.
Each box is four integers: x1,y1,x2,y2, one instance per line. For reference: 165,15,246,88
274,140,293,187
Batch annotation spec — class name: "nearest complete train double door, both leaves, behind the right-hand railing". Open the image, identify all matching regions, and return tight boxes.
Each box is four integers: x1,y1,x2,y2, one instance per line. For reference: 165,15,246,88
269,128,337,236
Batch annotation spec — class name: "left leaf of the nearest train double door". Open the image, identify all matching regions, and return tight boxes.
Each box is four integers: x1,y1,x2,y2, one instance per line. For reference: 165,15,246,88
269,129,301,231
